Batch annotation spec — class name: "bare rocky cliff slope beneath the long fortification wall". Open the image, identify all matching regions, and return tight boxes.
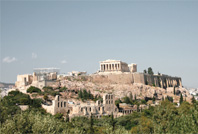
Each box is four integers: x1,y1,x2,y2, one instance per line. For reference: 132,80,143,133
60,78,192,102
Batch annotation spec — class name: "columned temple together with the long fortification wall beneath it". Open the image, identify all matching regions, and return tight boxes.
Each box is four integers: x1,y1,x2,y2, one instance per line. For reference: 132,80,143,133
91,60,182,88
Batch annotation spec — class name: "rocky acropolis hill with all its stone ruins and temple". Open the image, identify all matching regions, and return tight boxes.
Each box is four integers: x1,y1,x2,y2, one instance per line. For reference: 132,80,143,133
11,60,192,117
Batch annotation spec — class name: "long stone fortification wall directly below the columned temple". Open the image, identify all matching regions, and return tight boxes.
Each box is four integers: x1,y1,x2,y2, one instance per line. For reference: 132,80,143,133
90,73,182,88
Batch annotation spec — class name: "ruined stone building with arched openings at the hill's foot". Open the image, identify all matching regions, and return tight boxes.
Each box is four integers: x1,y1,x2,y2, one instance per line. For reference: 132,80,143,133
42,94,122,118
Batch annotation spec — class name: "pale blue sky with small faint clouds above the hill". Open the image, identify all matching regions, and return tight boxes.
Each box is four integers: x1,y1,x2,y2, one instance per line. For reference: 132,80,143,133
0,1,198,87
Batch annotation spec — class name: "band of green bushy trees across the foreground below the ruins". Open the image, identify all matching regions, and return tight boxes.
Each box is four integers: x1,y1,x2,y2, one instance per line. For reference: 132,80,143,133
0,92,198,134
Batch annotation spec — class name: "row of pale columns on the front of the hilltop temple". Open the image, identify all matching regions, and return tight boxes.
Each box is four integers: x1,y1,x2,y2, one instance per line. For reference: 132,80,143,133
100,63,121,72
